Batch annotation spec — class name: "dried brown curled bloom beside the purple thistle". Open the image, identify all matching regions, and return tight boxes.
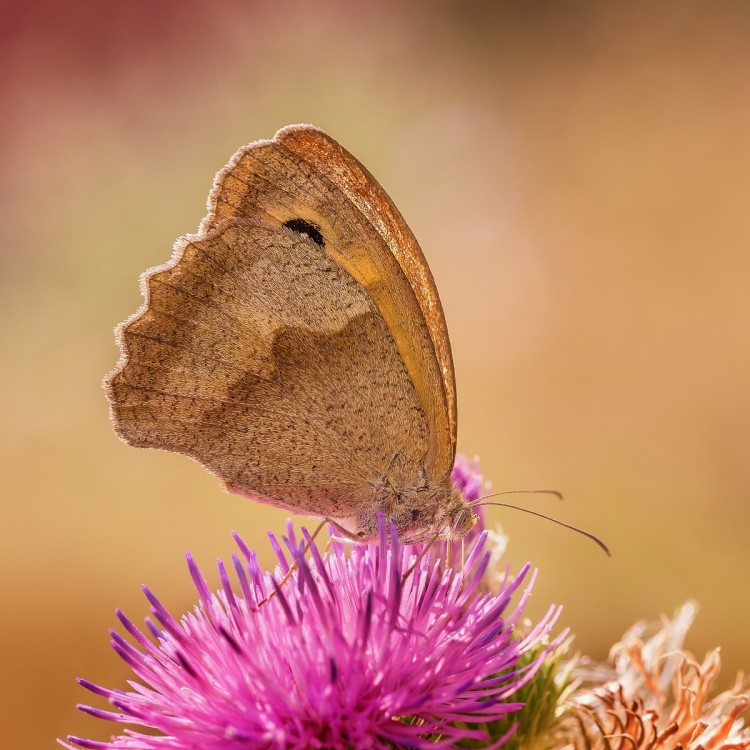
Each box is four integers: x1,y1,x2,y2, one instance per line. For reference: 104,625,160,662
556,603,750,750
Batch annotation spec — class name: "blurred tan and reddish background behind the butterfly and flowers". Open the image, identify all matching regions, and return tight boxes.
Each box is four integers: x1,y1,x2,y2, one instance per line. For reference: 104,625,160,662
0,0,750,748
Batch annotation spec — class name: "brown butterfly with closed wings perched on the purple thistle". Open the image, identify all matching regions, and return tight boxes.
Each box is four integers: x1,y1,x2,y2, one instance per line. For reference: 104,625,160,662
104,125,476,541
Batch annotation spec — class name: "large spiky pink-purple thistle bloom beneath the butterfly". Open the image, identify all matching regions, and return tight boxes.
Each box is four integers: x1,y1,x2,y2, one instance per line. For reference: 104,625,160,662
61,519,565,750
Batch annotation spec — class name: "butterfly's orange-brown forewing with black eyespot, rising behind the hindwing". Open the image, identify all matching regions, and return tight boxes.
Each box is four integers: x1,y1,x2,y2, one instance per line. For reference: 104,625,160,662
202,125,457,479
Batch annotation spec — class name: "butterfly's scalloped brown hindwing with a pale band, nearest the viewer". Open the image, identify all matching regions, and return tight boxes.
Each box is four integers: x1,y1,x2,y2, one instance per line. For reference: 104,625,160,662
106,216,429,518
